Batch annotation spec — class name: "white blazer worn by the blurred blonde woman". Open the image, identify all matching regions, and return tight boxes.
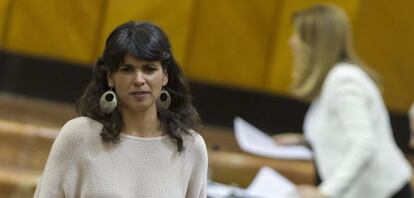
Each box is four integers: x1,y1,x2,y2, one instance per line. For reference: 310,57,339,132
304,63,411,198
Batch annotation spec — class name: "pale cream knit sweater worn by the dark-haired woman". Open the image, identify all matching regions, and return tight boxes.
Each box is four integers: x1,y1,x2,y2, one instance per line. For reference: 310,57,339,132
34,117,208,198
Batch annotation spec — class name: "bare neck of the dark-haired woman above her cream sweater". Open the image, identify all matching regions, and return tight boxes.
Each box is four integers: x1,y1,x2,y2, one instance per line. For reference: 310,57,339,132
123,108,163,137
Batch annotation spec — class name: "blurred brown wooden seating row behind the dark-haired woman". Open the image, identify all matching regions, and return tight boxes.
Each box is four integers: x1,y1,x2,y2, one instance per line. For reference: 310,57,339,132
0,94,410,198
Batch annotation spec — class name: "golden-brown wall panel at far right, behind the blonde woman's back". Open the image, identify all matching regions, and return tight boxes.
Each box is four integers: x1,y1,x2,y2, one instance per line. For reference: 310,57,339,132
354,0,414,113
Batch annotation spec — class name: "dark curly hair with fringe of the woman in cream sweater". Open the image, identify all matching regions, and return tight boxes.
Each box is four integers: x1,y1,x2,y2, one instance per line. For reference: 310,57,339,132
76,21,200,151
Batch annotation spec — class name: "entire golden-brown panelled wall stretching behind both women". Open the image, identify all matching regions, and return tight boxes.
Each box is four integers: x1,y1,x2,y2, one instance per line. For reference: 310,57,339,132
0,0,414,112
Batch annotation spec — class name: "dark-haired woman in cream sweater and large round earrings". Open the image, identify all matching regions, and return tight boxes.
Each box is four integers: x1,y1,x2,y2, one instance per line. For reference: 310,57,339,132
35,21,207,198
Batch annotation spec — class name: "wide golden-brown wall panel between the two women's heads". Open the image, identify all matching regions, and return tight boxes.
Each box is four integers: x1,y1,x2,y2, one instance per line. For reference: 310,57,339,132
186,0,282,90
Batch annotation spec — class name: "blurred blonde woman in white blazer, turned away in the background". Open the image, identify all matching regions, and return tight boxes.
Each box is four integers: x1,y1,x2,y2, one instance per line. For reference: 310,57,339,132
275,4,411,198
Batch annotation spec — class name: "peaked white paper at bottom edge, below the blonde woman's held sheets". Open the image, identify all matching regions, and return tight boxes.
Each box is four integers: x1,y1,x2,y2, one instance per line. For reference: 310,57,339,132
246,166,298,198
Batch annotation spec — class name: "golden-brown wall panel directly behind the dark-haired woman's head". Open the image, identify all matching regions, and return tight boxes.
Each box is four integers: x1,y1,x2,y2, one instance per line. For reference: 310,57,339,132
96,0,193,71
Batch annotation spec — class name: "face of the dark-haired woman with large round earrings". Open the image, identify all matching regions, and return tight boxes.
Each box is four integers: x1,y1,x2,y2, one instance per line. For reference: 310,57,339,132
108,53,168,112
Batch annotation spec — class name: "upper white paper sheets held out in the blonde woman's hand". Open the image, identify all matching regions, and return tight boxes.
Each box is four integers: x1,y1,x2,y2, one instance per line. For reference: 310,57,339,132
234,117,312,160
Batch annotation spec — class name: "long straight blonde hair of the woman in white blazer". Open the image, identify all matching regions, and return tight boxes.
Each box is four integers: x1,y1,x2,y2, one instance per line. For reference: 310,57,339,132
291,4,378,100
